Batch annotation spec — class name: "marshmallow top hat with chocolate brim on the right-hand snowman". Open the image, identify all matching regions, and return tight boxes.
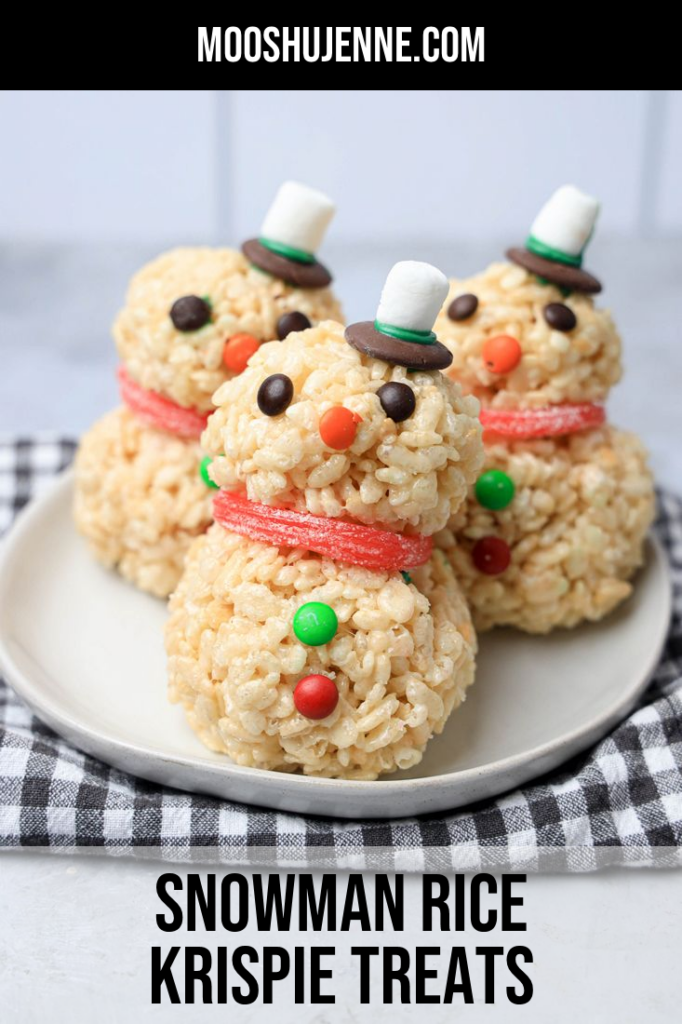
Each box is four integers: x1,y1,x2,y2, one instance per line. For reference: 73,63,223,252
507,185,601,294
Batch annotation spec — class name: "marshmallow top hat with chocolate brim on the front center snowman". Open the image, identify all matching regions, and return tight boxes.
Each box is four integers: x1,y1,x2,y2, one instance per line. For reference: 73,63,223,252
345,260,453,370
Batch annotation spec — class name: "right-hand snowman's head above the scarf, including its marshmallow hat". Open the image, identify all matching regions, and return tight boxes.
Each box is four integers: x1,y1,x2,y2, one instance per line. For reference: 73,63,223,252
436,185,621,409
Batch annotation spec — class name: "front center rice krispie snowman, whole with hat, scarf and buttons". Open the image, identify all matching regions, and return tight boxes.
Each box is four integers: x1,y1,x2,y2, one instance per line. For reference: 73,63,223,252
166,262,482,779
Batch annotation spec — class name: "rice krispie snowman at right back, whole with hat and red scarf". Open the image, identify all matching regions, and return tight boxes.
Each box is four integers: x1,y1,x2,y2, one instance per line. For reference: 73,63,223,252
436,185,654,633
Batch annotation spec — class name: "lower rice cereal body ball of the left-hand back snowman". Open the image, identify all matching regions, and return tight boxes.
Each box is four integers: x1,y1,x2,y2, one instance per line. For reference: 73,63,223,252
74,409,212,597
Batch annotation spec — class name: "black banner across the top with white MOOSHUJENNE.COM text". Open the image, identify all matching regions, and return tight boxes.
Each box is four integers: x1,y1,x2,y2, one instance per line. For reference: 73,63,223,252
2,16,677,89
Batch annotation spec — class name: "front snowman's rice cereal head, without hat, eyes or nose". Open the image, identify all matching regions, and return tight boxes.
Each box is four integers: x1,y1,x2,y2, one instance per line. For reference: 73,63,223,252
202,321,483,535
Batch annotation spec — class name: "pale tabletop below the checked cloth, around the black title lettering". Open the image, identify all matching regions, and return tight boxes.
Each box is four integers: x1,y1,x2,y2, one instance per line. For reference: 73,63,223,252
0,853,682,1024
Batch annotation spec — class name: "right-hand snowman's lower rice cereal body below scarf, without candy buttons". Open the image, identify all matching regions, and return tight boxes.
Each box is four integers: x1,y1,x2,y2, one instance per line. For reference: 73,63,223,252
435,426,654,633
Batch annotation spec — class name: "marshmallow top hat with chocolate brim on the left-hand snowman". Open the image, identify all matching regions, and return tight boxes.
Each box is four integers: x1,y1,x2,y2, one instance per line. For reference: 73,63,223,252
242,181,336,288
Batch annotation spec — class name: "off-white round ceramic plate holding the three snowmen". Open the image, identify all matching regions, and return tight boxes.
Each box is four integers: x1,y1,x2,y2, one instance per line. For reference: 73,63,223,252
0,474,671,818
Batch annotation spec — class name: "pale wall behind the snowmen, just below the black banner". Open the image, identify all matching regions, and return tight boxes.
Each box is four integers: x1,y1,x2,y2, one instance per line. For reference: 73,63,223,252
0,91,682,245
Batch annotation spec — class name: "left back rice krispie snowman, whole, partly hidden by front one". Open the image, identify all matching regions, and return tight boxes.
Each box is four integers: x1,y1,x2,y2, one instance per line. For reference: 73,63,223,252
75,181,340,597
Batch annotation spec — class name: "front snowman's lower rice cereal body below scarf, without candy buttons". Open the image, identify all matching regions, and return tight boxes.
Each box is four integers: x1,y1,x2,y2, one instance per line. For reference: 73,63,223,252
166,524,476,779
